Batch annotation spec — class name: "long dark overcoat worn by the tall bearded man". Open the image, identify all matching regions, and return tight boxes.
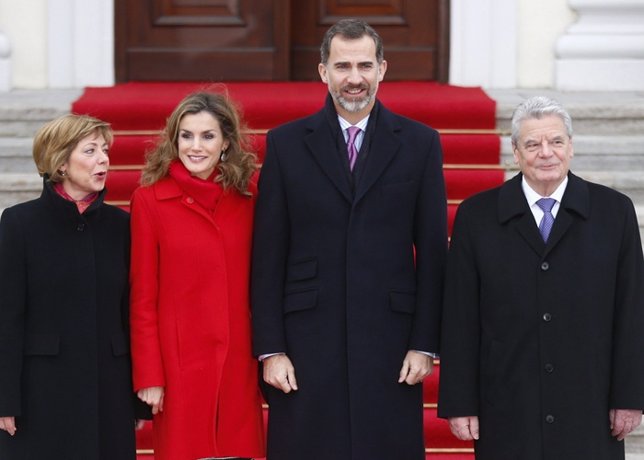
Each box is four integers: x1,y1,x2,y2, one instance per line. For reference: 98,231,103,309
251,99,447,460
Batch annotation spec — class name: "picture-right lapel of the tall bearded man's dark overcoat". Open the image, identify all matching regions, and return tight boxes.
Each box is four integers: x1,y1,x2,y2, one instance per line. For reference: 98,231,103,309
355,105,400,203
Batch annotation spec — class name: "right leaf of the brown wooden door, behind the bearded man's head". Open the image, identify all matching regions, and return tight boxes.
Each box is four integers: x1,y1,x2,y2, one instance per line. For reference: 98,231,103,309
291,0,449,82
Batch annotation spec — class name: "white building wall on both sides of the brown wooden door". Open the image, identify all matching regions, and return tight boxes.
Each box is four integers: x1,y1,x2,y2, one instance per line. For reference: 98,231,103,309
0,0,644,91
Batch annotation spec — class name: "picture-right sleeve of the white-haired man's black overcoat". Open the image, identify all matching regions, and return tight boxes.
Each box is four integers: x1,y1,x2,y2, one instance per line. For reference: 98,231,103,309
610,198,644,409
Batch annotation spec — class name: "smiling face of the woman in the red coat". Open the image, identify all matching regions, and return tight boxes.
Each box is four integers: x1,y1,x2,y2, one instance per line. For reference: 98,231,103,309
177,111,228,179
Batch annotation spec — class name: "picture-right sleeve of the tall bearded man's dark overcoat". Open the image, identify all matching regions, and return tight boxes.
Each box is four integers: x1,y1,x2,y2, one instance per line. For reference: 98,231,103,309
409,131,447,353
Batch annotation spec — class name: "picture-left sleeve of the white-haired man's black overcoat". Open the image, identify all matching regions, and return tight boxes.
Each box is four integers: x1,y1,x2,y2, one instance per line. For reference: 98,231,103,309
438,205,480,418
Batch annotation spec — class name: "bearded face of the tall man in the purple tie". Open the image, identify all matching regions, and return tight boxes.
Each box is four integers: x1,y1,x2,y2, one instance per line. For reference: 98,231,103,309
318,35,387,123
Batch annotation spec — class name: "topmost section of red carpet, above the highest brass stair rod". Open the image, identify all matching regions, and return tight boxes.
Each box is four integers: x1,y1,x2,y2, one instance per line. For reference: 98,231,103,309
72,81,495,130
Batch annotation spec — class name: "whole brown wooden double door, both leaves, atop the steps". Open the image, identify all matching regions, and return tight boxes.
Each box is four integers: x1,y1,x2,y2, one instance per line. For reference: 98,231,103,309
115,0,449,82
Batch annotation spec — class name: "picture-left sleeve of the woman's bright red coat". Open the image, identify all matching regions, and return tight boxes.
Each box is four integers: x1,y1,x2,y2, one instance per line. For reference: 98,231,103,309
130,189,165,390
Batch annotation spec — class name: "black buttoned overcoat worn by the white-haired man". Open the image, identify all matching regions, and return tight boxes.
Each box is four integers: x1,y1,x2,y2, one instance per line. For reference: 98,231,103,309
438,173,644,460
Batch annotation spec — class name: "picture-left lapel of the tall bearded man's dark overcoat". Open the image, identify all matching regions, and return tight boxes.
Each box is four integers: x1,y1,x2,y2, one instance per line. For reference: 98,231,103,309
304,110,353,202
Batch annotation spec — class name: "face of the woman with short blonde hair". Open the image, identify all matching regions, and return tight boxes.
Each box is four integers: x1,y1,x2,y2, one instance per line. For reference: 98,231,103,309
60,133,110,200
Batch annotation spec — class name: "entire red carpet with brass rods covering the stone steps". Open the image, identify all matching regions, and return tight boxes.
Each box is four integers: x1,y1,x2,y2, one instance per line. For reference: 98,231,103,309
72,81,494,460
